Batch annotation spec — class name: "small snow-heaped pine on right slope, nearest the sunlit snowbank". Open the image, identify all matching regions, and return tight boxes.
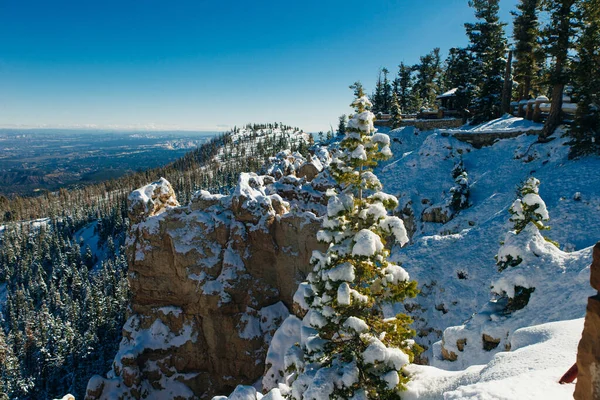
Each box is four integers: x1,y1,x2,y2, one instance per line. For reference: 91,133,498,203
492,177,554,313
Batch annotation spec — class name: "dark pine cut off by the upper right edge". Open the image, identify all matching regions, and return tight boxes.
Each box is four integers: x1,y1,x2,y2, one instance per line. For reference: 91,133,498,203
569,0,600,157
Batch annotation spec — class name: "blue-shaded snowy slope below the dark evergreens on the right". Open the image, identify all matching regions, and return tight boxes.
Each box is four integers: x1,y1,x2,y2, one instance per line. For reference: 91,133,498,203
377,123,600,359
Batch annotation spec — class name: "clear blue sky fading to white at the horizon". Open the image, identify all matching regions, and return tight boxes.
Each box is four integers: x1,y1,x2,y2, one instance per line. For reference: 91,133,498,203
0,0,517,131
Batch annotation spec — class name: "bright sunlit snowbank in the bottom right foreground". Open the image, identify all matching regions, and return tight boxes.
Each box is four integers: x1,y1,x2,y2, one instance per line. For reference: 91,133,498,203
402,318,583,400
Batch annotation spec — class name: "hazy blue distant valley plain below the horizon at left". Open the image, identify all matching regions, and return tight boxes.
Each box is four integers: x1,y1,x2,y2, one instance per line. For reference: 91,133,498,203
0,129,217,195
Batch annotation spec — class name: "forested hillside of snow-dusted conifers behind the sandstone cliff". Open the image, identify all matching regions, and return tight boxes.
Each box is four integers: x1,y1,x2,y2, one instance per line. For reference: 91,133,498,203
0,123,309,399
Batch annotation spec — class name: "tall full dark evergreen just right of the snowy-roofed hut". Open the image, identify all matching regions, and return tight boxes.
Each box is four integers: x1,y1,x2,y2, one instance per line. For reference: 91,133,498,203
465,0,506,122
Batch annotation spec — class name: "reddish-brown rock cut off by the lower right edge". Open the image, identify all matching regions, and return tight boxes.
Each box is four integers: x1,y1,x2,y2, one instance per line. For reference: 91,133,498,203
573,242,600,400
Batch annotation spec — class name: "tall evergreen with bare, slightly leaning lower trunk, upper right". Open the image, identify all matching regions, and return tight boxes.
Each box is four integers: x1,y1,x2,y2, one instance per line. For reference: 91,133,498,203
540,0,580,140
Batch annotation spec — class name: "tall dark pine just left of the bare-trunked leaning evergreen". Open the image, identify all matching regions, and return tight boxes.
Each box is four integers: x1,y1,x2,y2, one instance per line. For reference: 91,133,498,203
511,0,541,100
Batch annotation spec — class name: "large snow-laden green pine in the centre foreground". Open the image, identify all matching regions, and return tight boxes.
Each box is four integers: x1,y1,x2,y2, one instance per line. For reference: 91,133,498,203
287,89,418,400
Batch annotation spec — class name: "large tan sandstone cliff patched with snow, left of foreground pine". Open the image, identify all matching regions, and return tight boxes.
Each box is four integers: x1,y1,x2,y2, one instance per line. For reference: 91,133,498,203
86,152,327,400
